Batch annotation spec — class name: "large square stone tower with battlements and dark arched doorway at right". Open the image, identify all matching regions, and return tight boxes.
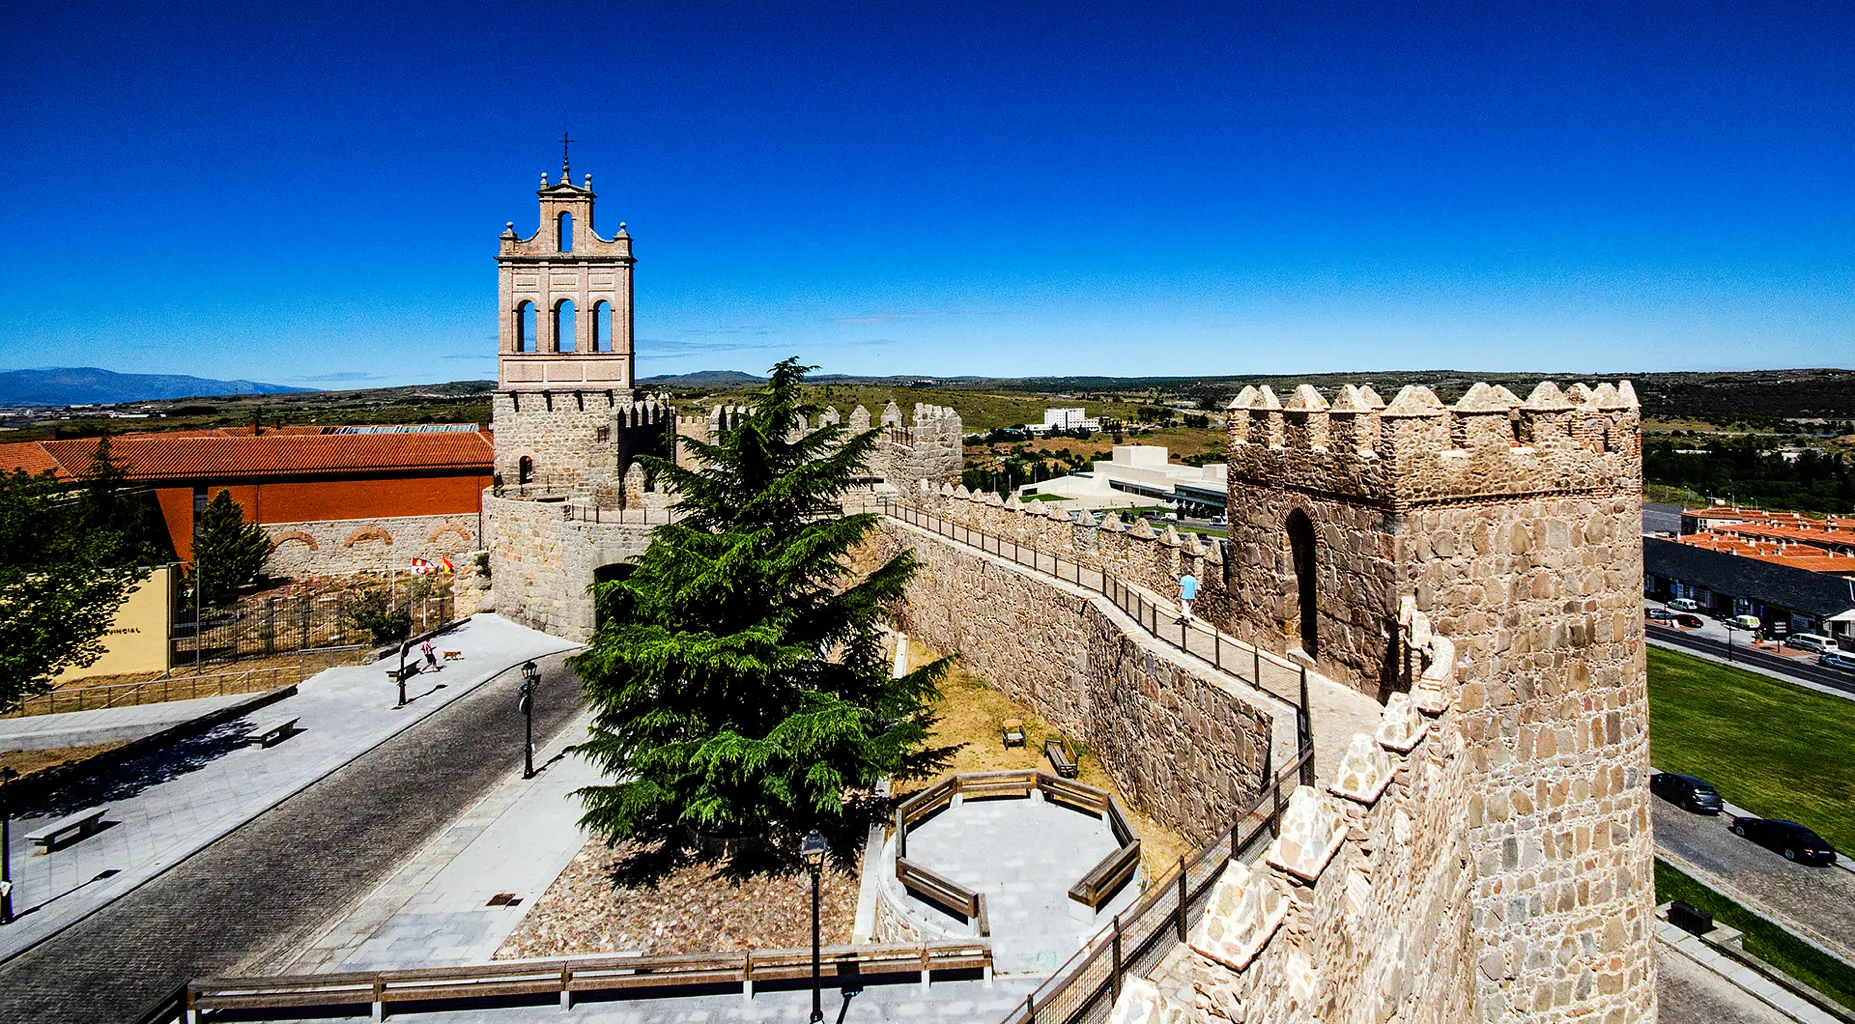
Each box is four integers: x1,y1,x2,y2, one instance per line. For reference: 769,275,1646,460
1230,384,1655,1020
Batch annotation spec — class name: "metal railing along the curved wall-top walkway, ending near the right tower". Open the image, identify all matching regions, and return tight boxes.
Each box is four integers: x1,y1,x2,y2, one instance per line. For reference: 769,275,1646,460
883,503,1308,709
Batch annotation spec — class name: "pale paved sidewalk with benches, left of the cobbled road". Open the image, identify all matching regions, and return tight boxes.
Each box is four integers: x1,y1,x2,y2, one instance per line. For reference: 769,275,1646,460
0,616,573,963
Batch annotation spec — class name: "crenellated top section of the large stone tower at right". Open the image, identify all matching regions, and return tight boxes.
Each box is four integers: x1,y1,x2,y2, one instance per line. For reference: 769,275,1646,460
1228,380,1642,510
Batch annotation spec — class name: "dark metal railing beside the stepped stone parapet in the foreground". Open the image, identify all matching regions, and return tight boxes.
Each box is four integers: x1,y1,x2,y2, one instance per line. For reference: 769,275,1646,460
1004,746,1313,1024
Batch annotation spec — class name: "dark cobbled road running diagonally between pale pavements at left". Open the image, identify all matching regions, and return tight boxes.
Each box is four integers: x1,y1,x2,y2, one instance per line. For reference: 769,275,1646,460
0,655,584,1024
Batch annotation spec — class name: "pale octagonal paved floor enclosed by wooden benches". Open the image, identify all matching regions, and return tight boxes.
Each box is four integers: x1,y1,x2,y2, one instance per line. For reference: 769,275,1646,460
877,796,1141,974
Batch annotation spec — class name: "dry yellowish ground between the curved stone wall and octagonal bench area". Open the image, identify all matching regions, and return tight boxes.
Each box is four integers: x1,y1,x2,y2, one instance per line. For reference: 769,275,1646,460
896,640,1196,879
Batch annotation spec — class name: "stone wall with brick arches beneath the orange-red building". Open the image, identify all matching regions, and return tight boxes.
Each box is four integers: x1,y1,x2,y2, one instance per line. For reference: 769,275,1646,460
263,512,477,577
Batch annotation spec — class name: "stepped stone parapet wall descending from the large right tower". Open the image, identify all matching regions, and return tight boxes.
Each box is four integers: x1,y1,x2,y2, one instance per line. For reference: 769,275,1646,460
1117,612,1476,1024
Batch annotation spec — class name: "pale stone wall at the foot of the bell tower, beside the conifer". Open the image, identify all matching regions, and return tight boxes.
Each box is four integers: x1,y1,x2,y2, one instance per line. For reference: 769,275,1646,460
482,493,651,640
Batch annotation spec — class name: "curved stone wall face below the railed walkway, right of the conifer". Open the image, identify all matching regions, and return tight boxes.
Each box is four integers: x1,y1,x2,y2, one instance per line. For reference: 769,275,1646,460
872,518,1271,842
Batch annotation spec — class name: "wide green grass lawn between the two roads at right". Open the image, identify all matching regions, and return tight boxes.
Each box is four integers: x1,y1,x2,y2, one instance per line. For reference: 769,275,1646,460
1649,647,1855,857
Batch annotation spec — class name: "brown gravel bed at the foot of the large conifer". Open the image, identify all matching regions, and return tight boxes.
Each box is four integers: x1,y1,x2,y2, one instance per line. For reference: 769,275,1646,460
495,838,857,959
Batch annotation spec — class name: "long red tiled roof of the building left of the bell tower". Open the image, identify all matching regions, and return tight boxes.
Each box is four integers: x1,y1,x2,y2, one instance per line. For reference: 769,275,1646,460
21,432,493,480
